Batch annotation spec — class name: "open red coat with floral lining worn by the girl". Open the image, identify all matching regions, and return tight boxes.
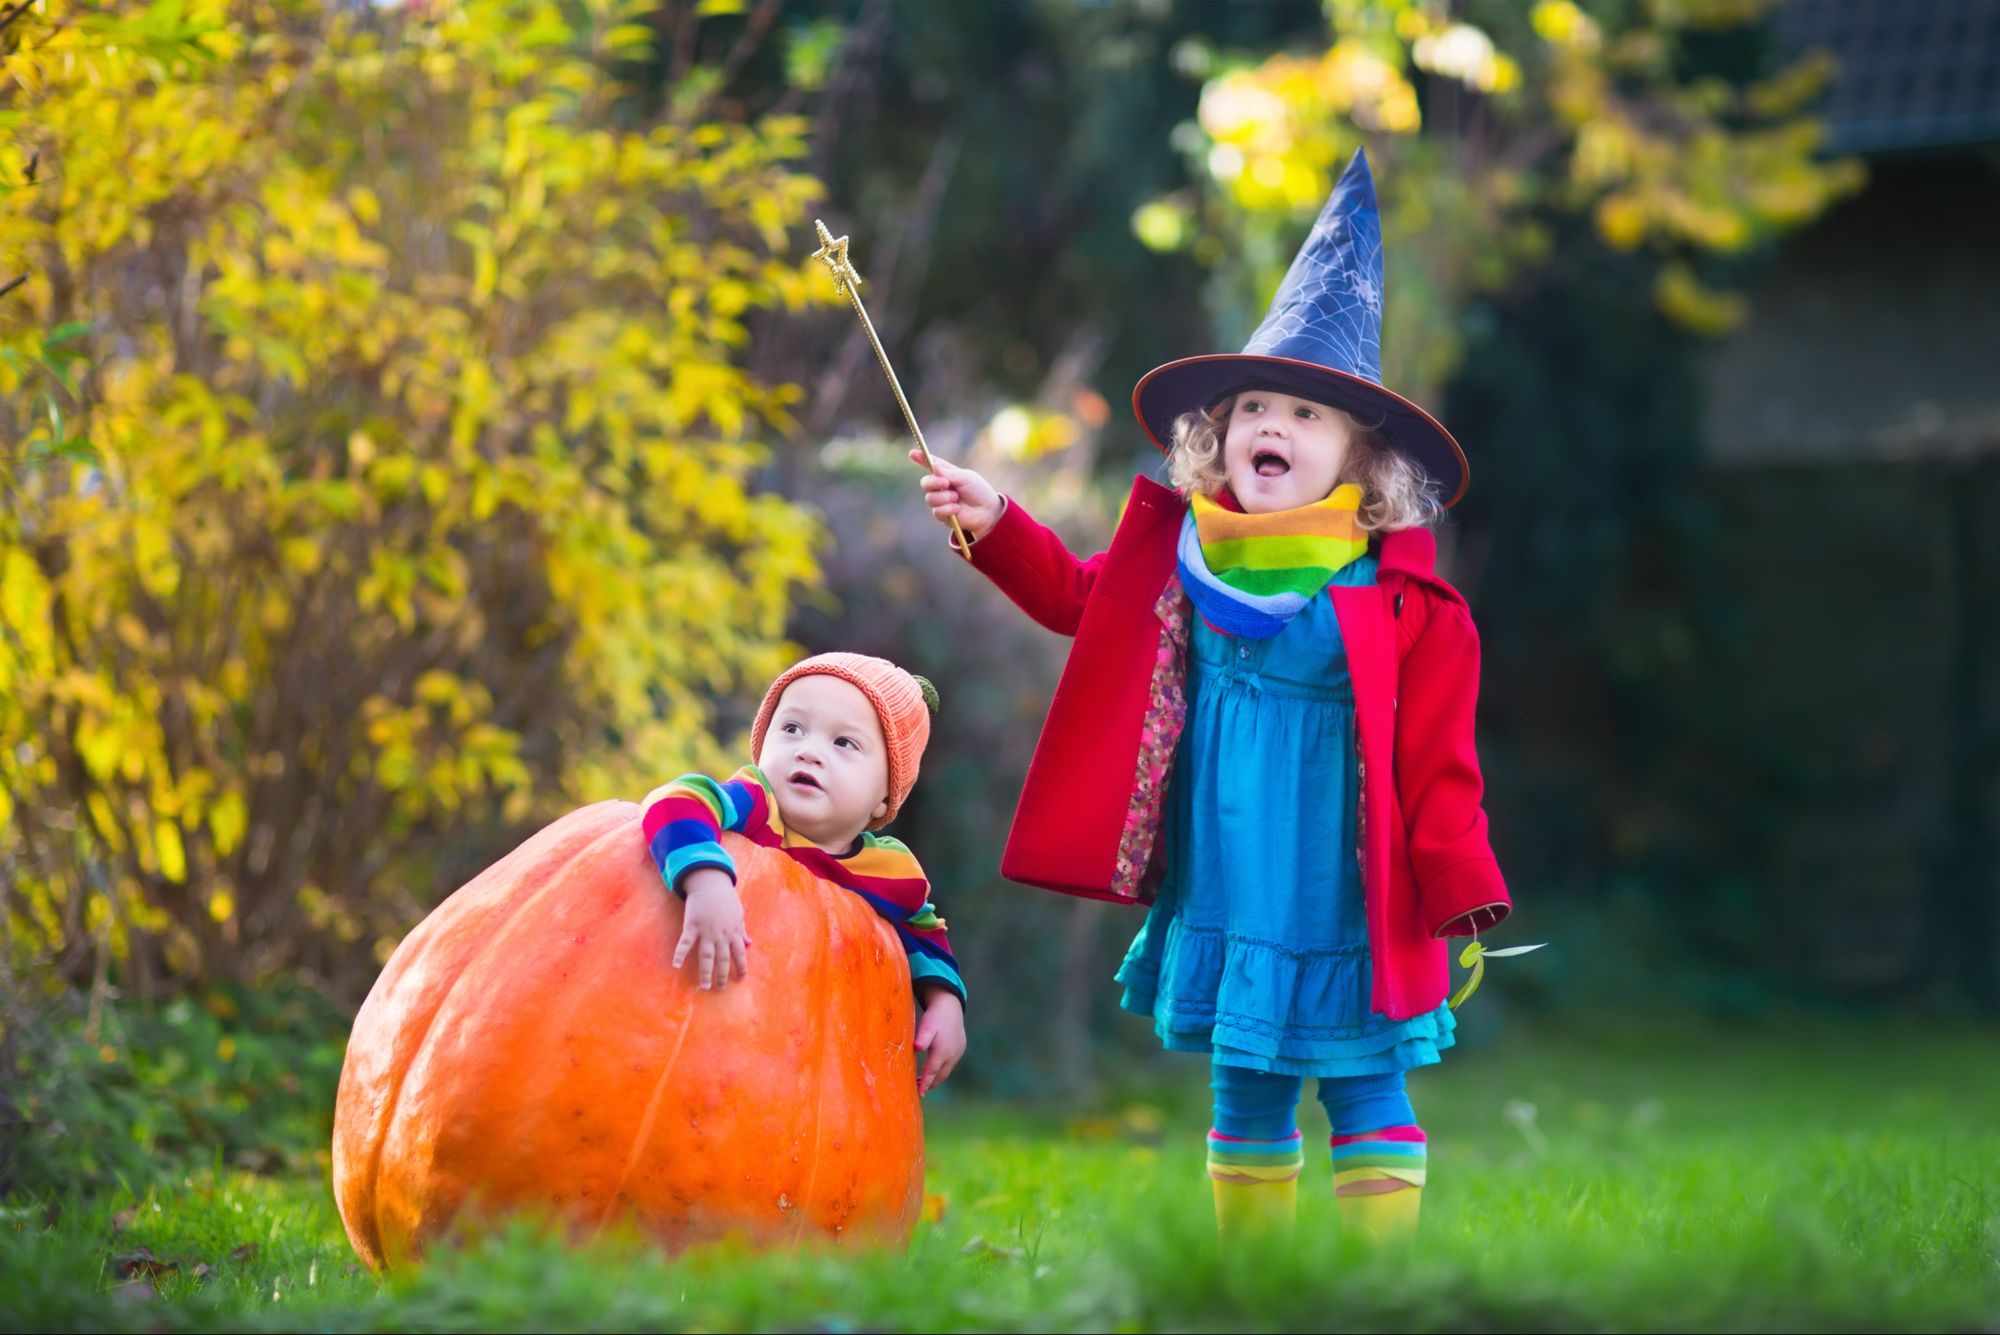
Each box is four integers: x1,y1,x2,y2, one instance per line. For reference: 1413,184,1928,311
972,478,1512,1019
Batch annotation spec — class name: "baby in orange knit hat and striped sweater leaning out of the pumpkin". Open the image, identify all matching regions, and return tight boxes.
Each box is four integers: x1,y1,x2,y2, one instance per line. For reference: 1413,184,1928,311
644,654,966,1093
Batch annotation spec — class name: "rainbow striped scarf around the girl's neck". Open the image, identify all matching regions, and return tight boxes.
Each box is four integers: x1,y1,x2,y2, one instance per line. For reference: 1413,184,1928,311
1180,482,1368,640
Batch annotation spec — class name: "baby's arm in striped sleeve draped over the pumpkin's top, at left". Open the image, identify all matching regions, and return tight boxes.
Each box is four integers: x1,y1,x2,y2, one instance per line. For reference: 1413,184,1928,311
640,773,766,989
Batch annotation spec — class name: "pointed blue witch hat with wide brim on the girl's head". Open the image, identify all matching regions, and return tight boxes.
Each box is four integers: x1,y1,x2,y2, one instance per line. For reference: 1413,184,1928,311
1132,150,1470,506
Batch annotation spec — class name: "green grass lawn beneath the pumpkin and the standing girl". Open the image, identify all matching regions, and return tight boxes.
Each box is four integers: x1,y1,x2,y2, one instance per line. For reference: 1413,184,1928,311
0,1027,2000,1331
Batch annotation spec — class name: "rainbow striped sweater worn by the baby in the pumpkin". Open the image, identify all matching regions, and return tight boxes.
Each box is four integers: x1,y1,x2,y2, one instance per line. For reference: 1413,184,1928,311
640,765,966,1001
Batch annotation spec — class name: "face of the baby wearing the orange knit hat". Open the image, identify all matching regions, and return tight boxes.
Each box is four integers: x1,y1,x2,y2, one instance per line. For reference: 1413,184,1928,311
756,673,888,853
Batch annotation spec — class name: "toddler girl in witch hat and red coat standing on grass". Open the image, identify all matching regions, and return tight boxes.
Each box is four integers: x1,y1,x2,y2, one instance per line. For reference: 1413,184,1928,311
924,154,1510,1235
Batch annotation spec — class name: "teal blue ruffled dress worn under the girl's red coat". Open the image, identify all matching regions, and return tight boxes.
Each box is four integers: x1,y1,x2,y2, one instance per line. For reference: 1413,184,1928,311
1118,556,1452,1077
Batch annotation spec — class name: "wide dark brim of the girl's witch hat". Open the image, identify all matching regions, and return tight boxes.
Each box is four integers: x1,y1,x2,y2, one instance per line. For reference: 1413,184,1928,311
1132,352,1472,510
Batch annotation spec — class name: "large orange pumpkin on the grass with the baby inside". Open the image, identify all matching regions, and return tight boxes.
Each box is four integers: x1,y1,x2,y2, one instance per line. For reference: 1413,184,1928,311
334,801,924,1269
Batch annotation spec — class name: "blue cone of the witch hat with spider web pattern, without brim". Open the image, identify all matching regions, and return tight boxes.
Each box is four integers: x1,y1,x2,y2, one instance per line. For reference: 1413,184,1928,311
1244,158,1382,384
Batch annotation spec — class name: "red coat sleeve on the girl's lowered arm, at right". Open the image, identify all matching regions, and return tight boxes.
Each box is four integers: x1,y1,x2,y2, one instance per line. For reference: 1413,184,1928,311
1396,598,1514,937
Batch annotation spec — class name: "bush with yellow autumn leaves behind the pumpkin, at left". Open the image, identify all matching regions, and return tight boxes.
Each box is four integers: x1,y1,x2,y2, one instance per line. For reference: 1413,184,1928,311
0,0,828,983
